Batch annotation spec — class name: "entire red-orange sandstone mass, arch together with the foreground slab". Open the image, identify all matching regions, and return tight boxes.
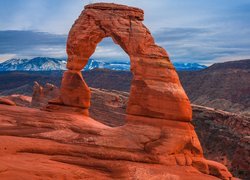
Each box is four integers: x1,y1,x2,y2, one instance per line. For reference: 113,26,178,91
0,3,232,179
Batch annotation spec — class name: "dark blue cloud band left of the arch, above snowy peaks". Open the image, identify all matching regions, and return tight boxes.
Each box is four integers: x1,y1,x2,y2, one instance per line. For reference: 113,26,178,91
0,31,67,57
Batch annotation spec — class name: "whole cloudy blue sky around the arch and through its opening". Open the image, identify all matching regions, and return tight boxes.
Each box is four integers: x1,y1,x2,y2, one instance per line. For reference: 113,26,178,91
0,0,250,65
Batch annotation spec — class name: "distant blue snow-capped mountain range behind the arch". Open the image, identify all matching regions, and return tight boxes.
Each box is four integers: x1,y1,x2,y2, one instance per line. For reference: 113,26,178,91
0,57,206,71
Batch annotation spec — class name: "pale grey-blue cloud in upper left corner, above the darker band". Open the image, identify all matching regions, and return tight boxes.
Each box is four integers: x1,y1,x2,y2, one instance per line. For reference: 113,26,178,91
0,0,86,34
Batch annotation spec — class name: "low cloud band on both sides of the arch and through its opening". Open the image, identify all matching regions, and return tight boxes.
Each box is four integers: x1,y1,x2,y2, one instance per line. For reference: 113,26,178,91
0,24,250,65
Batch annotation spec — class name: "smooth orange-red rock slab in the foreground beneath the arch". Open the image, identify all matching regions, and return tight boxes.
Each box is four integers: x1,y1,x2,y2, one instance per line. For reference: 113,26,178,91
0,105,229,179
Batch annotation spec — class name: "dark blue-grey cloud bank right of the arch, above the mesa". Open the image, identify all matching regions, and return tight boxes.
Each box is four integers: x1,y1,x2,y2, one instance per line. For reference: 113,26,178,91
153,27,250,65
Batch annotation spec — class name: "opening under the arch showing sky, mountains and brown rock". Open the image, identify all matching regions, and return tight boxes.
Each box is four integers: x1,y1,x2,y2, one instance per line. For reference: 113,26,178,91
86,37,131,127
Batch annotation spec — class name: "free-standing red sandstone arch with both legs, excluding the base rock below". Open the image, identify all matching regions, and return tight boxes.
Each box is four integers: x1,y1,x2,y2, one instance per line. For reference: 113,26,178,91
60,3,192,121
